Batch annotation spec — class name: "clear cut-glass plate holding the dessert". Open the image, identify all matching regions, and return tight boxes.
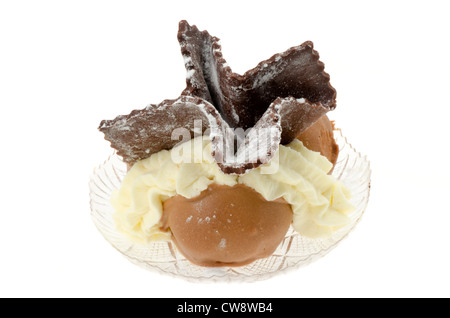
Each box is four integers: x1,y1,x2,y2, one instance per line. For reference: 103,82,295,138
89,130,371,281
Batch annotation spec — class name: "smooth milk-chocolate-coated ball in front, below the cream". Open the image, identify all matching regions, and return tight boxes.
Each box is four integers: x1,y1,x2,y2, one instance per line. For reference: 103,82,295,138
162,184,292,267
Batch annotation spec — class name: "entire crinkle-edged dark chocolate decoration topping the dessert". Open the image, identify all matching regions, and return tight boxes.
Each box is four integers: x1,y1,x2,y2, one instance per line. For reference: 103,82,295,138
99,21,336,174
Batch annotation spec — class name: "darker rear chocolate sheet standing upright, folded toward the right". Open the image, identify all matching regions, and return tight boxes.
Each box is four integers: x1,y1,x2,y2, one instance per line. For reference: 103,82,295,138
178,21,336,139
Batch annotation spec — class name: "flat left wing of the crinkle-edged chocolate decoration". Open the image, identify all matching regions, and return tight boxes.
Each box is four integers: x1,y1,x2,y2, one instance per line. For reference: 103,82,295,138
99,96,214,164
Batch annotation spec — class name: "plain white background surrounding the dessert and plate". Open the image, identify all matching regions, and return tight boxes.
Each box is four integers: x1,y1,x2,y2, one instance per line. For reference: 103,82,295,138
0,0,450,297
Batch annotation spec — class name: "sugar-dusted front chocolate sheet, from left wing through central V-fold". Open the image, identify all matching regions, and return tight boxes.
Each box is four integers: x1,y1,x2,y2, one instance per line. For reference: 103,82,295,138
99,96,281,174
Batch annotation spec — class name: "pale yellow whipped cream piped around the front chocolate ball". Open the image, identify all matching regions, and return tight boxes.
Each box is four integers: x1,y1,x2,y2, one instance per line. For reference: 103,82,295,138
111,137,354,243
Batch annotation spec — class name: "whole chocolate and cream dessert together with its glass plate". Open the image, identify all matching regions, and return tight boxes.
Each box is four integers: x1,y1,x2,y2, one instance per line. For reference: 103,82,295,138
90,21,370,280
